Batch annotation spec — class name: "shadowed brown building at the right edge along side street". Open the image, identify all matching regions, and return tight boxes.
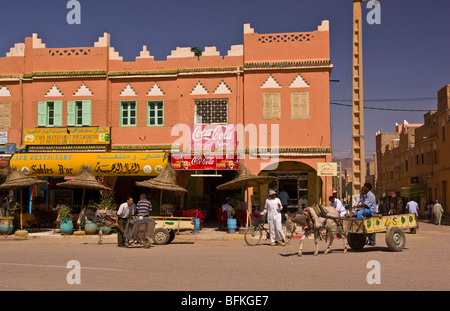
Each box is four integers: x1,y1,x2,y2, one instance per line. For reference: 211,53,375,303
376,85,450,217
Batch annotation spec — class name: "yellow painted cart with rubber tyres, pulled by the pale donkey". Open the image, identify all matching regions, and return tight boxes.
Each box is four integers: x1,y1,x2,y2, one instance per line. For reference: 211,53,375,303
330,214,417,252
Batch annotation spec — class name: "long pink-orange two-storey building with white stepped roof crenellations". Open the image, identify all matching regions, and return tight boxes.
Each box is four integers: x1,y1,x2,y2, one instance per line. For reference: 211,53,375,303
0,21,333,216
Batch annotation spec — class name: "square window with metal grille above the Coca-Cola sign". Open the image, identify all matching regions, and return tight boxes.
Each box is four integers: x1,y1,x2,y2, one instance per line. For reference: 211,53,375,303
194,99,228,124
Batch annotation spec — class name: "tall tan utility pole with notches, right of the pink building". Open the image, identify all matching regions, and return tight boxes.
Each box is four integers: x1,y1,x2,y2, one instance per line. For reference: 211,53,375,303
352,0,367,195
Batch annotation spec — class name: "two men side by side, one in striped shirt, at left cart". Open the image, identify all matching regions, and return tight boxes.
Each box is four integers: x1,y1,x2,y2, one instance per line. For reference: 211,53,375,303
116,194,152,247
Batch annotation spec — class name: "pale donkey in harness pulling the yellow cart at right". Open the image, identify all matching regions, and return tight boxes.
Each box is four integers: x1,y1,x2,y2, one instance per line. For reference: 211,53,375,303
286,207,348,257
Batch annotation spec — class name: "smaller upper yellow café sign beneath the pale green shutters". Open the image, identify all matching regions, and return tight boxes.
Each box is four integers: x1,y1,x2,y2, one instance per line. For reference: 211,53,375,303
24,127,111,145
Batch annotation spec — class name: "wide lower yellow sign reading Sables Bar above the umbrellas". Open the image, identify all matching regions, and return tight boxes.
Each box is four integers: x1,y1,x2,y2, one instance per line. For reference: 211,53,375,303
10,152,167,177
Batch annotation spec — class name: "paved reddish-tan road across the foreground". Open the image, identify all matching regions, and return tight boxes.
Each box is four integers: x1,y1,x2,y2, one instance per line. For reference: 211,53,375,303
0,223,450,291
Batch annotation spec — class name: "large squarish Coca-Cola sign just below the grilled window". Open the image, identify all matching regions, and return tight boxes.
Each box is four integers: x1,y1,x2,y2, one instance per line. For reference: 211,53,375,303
190,124,237,154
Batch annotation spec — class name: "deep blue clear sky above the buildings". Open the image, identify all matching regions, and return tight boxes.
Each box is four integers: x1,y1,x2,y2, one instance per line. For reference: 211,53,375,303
0,0,450,158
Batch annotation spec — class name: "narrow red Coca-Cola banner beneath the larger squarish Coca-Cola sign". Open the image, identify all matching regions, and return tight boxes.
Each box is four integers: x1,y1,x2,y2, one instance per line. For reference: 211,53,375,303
172,154,239,170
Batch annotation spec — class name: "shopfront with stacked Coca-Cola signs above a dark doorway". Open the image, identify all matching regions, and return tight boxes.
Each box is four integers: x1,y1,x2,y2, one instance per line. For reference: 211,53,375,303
171,124,243,224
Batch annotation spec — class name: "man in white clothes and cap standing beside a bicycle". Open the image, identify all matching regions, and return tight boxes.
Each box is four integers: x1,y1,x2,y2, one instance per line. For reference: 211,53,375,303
261,190,286,246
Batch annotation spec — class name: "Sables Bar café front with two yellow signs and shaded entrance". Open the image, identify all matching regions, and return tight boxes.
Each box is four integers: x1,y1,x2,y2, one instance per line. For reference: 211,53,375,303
10,127,168,212
